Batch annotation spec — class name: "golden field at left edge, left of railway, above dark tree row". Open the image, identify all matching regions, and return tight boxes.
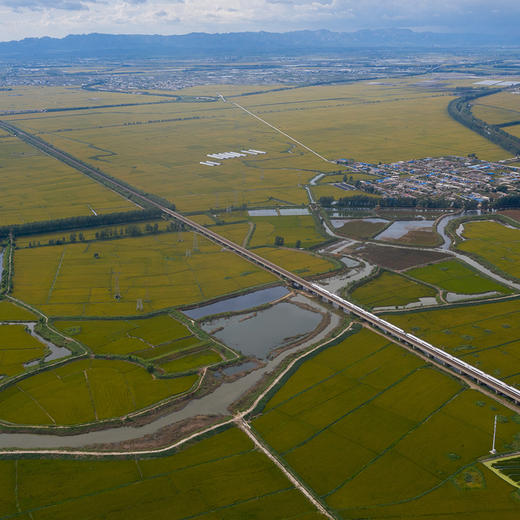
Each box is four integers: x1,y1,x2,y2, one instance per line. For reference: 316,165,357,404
0,133,137,225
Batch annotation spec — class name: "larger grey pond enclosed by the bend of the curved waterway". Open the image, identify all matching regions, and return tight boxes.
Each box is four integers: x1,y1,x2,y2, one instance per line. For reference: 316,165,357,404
201,302,322,359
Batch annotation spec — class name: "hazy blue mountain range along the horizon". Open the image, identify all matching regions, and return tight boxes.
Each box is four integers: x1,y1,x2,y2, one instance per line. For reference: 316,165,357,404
0,29,520,60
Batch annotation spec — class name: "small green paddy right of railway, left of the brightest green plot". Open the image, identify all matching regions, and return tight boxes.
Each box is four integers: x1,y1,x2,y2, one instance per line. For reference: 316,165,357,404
351,272,437,307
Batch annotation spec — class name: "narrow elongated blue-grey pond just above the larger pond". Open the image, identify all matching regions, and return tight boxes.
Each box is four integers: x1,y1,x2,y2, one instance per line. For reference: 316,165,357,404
182,285,289,320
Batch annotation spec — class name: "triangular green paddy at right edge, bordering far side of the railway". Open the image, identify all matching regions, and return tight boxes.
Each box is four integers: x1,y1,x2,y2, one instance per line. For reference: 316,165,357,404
385,300,520,385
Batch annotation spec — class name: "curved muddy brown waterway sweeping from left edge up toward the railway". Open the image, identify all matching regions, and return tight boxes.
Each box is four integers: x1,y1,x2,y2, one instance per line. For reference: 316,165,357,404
0,295,341,449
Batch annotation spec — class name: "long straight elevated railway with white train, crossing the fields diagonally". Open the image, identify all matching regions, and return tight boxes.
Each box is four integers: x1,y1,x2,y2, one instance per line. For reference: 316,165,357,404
0,121,520,405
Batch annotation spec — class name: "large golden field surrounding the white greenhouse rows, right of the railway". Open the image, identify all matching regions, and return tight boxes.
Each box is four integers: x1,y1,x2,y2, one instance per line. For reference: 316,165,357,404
5,98,335,211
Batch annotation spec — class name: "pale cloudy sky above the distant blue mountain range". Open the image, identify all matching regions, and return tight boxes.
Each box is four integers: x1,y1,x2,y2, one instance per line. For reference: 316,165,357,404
0,0,520,41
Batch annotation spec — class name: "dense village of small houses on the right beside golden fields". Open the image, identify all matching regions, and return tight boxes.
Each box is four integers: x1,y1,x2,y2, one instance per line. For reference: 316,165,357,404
338,156,520,203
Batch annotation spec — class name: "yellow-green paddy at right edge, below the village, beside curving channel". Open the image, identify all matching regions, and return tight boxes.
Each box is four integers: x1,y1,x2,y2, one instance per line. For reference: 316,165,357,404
457,221,520,278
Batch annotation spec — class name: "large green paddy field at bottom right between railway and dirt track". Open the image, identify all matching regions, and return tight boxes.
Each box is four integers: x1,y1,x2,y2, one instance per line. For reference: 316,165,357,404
253,330,520,520
